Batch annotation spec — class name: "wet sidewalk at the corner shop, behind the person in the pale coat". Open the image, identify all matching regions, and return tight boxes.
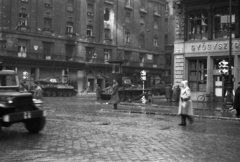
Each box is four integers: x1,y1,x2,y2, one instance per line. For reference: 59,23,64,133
78,93,240,121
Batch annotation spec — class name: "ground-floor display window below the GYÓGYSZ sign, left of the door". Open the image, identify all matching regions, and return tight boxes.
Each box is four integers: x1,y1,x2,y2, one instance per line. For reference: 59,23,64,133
188,59,207,92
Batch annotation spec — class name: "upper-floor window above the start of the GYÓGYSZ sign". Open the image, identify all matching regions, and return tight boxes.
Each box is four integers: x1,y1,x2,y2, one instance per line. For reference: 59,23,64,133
188,10,208,40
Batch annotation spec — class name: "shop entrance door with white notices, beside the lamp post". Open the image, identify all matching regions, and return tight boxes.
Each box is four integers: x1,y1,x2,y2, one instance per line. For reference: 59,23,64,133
213,75,225,101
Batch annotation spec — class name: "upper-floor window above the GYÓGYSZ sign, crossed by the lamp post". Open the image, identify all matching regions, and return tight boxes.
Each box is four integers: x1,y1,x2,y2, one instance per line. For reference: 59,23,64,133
213,7,235,39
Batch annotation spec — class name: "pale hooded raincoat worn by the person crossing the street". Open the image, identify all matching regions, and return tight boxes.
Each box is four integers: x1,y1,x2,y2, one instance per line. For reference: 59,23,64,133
178,81,193,115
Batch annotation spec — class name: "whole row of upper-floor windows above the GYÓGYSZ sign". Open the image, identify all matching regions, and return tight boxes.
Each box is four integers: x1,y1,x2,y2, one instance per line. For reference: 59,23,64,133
186,6,240,40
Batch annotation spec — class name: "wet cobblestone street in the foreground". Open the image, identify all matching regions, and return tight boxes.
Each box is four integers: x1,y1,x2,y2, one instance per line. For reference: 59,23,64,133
0,97,240,162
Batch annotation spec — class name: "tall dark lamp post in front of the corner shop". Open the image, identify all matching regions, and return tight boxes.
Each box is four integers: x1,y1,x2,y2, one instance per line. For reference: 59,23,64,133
226,0,233,108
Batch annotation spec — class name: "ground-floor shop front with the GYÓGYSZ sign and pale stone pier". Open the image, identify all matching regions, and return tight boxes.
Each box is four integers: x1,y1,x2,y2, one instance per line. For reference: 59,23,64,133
174,40,240,101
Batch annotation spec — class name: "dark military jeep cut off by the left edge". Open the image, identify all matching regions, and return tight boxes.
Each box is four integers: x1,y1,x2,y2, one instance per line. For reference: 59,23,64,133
0,70,46,133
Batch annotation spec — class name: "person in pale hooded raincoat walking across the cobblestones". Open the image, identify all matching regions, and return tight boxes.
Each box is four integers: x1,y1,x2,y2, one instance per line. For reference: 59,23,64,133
178,80,193,126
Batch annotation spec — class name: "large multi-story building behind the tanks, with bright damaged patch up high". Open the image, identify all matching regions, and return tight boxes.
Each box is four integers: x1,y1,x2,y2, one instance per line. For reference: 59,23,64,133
0,0,168,92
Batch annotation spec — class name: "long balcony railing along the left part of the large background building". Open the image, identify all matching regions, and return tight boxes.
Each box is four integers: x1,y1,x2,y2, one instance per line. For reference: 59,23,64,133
0,50,84,62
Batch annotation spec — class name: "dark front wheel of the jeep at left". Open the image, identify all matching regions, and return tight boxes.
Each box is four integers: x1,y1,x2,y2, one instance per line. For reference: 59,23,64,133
25,117,46,133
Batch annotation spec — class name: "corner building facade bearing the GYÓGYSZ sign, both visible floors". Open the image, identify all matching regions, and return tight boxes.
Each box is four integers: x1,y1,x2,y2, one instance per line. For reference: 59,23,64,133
174,0,240,101
